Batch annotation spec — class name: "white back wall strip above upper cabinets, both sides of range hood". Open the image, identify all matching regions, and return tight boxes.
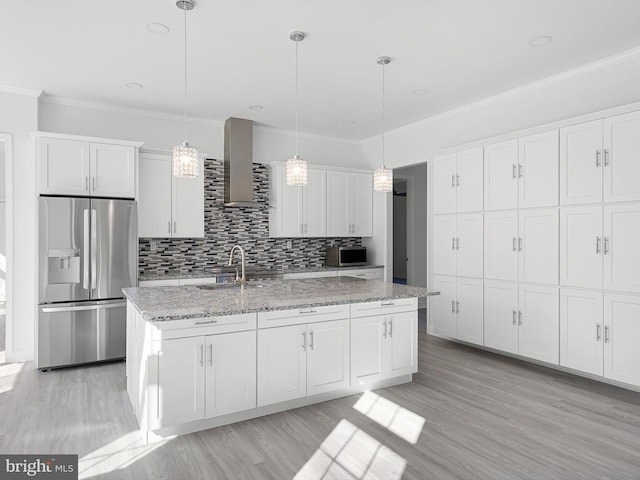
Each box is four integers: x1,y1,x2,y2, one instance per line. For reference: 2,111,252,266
38,97,365,168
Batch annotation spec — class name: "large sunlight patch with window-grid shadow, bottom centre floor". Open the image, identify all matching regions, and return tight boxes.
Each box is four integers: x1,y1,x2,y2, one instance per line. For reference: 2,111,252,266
294,419,407,480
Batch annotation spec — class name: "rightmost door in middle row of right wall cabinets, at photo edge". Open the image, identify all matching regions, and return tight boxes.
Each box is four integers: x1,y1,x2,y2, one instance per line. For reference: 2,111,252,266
603,203,640,293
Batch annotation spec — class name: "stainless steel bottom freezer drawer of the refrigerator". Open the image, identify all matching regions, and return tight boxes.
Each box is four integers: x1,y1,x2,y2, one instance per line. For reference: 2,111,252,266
36,300,126,369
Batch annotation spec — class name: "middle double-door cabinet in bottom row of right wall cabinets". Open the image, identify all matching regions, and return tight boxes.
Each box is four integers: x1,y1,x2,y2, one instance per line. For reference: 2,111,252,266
484,280,559,364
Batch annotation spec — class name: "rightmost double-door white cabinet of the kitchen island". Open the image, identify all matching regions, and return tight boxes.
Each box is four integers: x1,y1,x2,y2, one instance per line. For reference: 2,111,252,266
351,302,418,387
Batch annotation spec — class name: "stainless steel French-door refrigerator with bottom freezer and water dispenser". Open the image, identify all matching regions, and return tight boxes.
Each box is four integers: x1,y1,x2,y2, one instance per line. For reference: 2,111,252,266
36,196,138,370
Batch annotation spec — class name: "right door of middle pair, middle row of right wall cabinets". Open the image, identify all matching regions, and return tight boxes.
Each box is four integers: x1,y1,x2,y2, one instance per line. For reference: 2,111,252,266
518,208,559,284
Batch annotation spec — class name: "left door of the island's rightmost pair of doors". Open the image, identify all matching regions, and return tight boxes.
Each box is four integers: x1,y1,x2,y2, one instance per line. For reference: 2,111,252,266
351,315,387,388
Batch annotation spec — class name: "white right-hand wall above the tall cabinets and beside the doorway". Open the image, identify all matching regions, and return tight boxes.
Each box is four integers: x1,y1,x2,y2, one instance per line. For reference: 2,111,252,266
362,49,640,279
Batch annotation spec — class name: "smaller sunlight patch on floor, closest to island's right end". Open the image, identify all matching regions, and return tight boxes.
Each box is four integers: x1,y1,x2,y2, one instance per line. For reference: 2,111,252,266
353,392,424,445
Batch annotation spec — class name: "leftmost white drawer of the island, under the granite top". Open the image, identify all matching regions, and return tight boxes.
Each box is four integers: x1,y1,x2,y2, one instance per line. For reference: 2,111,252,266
152,313,256,340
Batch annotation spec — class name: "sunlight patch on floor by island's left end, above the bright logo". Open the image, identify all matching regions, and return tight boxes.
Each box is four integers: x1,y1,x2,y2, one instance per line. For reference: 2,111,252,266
78,430,166,479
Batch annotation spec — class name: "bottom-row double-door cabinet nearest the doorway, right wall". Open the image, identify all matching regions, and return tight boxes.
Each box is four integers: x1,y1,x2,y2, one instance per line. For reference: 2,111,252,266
430,275,484,345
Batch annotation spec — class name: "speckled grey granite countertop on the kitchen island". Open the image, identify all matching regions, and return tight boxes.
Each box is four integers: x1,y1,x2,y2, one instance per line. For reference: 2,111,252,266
123,277,439,322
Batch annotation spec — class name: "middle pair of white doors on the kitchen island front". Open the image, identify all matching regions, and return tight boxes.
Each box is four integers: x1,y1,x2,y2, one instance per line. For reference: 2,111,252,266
258,319,349,406
